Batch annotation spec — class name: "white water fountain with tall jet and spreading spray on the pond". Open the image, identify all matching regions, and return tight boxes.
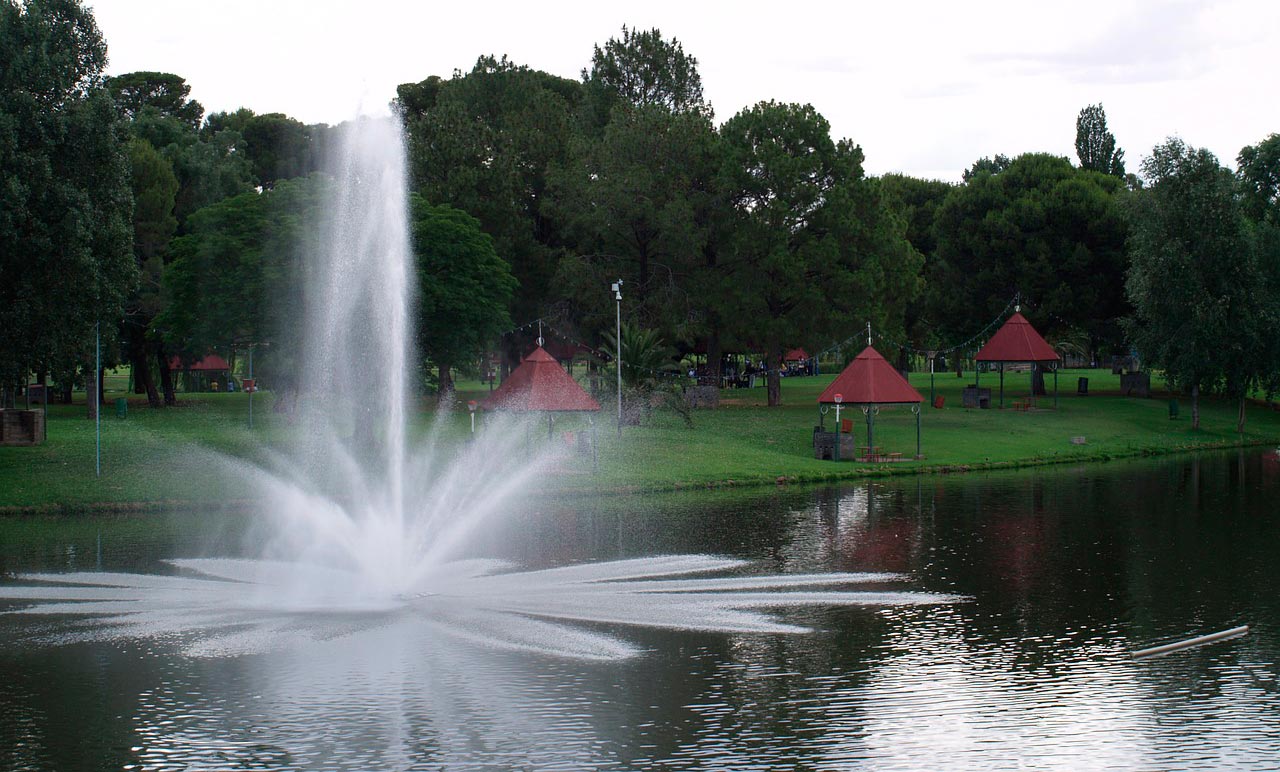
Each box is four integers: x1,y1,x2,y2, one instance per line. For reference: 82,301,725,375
0,119,952,659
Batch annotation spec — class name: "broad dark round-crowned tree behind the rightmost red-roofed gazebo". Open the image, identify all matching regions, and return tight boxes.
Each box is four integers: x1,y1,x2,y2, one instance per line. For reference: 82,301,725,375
927,154,1129,348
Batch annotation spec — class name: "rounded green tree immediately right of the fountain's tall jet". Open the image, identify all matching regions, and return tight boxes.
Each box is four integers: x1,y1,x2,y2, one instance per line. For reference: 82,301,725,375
410,193,516,394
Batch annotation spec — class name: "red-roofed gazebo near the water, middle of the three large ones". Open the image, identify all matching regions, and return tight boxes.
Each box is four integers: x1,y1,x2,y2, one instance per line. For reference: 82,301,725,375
814,346,924,461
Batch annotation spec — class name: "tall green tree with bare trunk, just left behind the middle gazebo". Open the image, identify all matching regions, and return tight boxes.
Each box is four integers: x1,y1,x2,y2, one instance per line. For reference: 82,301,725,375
717,101,920,406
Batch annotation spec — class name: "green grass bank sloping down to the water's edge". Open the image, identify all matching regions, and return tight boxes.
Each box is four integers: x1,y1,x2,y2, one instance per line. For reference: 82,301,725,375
0,370,1280,512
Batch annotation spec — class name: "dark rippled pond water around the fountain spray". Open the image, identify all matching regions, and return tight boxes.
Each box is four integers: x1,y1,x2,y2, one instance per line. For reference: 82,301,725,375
0,451,1280,771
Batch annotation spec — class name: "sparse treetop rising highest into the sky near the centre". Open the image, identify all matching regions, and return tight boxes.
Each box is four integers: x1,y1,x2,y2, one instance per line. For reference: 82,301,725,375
582,26,712,119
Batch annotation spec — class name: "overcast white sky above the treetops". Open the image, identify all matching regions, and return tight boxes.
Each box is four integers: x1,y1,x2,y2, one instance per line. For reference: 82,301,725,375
87,0,1280,181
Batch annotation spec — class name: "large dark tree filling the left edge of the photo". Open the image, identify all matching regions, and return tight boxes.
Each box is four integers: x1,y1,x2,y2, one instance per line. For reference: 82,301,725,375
0,0,137,402
